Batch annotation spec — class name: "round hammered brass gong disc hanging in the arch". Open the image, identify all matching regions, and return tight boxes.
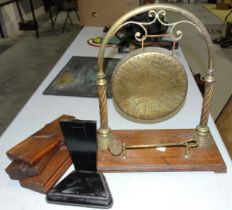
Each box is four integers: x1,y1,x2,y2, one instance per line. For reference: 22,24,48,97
112,48,187,120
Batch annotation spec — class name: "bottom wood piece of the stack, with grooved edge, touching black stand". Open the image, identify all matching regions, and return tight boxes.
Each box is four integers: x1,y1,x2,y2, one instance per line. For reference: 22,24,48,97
20,146,72,193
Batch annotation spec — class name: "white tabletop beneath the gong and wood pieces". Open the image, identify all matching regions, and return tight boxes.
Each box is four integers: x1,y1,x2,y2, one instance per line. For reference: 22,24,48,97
0,27,232,210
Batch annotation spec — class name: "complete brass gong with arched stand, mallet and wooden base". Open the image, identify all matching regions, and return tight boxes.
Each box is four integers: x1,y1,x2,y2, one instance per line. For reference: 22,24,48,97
97,4,226,172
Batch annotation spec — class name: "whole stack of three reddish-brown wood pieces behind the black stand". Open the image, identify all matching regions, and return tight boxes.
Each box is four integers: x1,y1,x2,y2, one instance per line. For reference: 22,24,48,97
6,115,74,193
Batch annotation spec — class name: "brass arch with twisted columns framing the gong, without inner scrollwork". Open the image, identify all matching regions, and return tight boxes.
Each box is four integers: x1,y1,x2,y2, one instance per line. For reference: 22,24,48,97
97,3,214,148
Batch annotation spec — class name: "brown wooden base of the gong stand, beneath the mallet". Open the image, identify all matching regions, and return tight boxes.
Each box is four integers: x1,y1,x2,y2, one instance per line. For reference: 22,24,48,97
97,129,226,173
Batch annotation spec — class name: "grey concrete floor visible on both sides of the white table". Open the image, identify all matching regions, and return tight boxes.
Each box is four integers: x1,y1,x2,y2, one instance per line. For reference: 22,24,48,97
0,3,232,135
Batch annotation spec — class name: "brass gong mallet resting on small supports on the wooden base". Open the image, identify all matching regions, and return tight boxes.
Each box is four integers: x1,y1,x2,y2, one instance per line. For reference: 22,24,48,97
109,139,198,158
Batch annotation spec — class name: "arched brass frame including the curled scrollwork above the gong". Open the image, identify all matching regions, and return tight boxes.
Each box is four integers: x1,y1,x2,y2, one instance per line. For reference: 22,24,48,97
97,3,214,148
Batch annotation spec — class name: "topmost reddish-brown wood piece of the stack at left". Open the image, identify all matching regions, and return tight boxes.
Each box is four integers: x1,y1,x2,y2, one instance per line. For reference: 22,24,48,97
7,115,74,165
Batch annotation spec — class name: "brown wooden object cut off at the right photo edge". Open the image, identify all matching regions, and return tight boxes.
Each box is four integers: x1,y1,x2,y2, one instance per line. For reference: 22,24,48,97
215,95,232,159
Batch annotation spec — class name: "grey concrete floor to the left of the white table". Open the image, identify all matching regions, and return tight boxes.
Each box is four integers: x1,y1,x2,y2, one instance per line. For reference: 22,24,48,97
0,11,81,135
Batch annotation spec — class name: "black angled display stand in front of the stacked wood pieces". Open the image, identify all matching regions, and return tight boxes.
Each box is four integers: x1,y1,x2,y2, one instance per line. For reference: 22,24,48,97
46,120,113,208
